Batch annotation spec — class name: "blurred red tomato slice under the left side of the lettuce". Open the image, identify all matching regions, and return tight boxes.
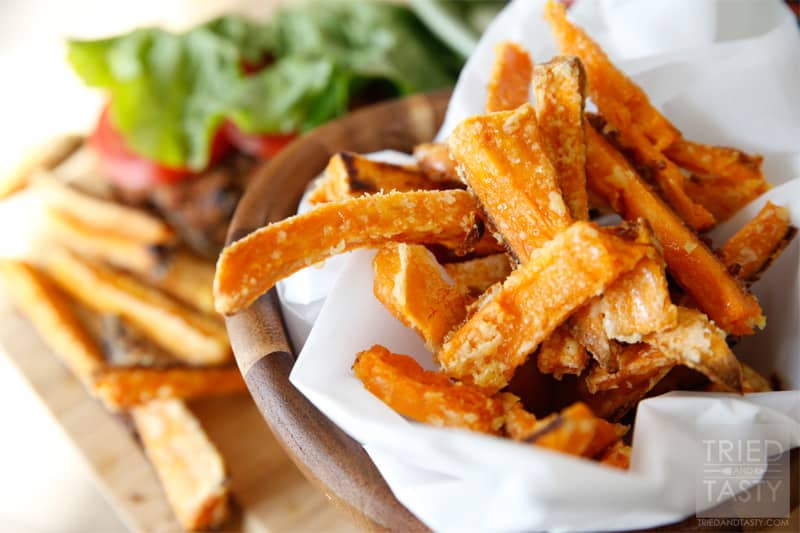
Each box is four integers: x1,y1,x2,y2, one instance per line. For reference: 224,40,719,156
89,106,230,190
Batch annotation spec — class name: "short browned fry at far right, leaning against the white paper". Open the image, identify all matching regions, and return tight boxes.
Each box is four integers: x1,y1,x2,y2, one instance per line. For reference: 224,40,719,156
719,202,797,283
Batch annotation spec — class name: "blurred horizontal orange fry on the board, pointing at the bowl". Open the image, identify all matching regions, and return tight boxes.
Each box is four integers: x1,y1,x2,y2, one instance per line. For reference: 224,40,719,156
92,365,247,410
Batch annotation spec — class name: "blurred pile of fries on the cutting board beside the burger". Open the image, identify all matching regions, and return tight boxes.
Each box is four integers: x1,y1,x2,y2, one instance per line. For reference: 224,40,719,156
0,149,245,530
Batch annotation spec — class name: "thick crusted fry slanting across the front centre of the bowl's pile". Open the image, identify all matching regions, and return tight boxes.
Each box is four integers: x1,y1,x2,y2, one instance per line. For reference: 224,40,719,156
438,222,652,390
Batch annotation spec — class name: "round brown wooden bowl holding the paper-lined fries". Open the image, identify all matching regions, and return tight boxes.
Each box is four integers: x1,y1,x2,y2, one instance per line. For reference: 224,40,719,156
225,91,450,531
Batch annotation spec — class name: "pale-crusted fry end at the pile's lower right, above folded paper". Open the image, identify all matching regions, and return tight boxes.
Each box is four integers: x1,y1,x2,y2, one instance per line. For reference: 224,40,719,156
644,307,742,392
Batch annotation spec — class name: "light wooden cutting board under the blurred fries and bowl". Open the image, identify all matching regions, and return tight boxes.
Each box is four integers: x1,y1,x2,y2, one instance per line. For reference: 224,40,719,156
0,294,355,533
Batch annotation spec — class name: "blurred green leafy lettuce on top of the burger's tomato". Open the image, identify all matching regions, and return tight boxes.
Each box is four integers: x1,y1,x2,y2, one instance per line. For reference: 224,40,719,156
68,0,460,170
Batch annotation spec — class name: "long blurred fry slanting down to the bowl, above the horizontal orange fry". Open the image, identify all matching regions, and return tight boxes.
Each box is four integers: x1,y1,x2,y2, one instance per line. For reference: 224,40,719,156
41,247,231,364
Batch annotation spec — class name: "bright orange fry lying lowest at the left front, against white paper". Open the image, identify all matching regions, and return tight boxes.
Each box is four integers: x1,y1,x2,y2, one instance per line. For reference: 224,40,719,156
353,345,504,433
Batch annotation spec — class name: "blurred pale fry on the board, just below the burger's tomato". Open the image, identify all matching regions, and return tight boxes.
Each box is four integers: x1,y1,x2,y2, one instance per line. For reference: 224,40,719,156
32,171,175,245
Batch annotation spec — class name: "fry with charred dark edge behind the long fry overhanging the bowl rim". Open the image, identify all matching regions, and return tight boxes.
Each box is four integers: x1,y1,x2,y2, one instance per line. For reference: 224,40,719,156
308,152,443,204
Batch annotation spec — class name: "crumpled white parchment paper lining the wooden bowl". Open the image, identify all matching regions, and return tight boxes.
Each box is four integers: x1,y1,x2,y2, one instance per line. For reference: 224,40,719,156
279,0,800,531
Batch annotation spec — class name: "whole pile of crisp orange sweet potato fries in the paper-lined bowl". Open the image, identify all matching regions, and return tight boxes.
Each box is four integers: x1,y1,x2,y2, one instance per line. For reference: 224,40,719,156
215,2,795,468
